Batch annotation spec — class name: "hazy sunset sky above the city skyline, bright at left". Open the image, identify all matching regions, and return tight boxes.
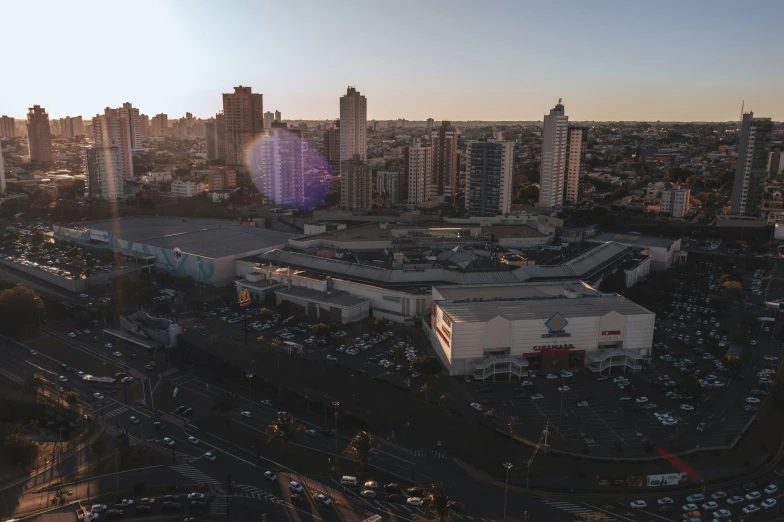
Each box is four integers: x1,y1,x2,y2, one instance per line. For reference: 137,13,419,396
0,0,784,120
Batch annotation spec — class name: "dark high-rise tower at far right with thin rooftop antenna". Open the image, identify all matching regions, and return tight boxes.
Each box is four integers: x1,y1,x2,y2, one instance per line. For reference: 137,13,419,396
732,112,773,217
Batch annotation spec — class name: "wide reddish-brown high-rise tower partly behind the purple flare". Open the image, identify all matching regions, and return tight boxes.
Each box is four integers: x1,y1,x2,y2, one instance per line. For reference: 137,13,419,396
223,85,264,165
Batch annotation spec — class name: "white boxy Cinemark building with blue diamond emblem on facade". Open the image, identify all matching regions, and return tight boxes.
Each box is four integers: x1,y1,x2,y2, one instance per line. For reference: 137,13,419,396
423,281,655,380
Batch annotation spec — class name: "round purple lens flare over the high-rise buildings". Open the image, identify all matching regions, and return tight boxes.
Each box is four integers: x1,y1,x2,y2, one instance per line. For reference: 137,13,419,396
245,128,331,209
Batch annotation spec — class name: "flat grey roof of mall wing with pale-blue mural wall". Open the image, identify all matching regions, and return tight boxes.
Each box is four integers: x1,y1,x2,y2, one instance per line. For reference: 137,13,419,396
86,217,299,258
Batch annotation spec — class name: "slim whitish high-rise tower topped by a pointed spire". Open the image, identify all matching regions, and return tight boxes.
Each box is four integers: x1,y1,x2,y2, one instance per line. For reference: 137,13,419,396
539,100,569,210
